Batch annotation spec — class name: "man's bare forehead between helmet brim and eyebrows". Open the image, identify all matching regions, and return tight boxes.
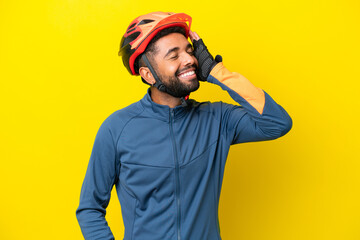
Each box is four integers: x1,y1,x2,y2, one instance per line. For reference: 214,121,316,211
155,33,189,54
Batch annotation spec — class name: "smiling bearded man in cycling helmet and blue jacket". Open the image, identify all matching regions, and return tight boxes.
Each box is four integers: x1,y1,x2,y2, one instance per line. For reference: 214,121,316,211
76,12,292,240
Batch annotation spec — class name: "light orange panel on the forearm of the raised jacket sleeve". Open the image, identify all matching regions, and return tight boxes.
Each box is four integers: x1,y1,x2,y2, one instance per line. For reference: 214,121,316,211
210,63,265,114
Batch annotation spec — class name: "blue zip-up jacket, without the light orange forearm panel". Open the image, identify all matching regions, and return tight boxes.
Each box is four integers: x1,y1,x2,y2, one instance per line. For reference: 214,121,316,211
76,68,292,240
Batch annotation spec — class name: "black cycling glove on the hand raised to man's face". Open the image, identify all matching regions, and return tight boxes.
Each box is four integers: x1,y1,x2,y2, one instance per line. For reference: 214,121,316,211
193,39,222,81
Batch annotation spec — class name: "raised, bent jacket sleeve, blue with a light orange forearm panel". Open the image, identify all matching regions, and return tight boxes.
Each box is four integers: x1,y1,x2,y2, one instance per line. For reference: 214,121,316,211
207,63,292,144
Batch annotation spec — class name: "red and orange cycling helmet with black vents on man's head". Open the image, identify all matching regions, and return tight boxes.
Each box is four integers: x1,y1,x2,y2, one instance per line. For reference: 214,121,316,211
118,12,191,75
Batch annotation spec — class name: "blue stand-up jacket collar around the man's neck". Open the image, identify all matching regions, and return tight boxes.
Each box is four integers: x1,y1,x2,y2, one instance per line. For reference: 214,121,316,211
140,88,191,122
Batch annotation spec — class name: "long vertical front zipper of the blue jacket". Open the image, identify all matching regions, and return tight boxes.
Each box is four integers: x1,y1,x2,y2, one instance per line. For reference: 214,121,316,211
170,109,181,240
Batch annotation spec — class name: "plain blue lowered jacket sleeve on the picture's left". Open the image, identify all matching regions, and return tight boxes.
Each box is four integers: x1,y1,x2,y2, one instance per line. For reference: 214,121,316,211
76,120,117,240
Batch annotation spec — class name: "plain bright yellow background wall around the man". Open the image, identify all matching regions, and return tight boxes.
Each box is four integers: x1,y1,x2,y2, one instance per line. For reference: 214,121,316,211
0,0,360,240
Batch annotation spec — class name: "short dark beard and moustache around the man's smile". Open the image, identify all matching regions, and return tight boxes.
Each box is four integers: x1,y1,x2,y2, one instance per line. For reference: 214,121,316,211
159,65,200,98
